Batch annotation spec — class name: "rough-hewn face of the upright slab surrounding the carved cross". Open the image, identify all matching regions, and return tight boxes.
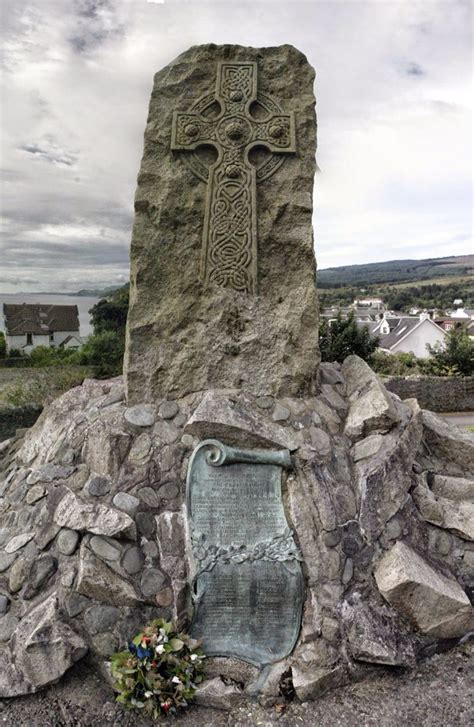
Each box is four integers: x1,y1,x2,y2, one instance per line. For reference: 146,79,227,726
125,45,319,404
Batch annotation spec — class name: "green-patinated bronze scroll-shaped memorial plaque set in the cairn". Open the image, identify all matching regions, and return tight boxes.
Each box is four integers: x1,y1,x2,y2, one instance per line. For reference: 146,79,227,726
187,440,303,666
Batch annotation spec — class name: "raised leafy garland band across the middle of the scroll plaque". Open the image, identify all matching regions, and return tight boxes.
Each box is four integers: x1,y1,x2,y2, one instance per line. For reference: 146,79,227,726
191,528,303,576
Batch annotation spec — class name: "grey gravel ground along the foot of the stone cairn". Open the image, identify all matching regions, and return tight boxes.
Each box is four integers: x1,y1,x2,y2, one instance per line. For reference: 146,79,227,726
0,642,474,727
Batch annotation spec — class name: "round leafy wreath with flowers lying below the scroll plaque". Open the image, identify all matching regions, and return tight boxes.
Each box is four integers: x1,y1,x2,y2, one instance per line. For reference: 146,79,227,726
110,619,204,719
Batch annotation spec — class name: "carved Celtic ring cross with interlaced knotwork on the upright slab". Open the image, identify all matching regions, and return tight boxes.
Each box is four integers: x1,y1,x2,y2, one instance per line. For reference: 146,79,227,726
171,62,296,293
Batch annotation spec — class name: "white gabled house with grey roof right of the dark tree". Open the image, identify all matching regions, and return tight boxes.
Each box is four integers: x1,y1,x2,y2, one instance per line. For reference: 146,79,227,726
371,312,446,358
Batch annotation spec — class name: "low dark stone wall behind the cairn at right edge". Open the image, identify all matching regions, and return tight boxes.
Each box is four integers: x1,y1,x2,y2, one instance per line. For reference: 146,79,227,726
383,376,474,411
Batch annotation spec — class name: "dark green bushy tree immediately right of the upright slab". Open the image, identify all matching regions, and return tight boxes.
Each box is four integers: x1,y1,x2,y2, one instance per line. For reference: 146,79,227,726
319,311,379,363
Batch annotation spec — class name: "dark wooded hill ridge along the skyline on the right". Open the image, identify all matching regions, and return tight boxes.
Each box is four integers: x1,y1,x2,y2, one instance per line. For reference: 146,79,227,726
318,255,474,289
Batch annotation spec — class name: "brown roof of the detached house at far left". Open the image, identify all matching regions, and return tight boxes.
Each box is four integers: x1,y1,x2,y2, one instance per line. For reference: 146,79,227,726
3,303,79,336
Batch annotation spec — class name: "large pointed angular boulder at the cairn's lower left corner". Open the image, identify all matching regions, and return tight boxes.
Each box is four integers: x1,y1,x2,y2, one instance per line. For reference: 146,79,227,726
7,593,87,696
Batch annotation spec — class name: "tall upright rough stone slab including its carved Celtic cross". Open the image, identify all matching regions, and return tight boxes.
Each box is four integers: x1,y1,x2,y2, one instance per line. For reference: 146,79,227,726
125,45,319,404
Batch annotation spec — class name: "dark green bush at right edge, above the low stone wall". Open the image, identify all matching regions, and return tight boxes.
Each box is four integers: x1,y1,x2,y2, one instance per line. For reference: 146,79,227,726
428,324,474,376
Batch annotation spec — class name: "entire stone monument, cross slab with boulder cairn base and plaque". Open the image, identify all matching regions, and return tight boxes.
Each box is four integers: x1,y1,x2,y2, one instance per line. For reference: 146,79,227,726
0,45,474,722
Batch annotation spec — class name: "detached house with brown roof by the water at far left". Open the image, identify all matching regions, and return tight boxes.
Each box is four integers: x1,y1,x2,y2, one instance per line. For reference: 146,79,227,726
3,303,82,354
